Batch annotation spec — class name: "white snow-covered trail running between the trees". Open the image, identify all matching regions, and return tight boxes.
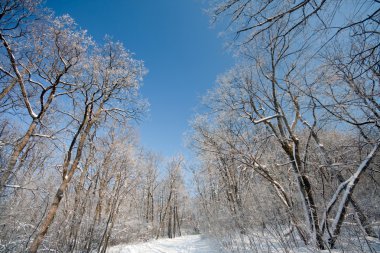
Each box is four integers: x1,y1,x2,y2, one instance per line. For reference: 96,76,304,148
107,235,221,253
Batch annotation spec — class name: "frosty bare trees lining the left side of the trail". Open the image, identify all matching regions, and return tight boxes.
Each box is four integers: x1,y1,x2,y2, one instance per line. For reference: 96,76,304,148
0,0,194,252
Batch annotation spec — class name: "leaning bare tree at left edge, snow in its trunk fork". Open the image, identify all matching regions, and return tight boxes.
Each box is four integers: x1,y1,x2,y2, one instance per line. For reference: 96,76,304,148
1,13,91,191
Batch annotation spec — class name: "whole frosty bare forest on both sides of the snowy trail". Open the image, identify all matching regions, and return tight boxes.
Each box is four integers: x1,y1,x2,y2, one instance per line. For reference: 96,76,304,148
0,0,380,253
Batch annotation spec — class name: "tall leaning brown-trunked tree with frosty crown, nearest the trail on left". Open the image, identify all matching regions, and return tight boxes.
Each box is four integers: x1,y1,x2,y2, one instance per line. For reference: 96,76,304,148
29,38,143,252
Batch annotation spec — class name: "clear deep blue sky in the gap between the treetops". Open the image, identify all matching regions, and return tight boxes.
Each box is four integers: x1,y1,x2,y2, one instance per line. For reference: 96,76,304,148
46,0,232,157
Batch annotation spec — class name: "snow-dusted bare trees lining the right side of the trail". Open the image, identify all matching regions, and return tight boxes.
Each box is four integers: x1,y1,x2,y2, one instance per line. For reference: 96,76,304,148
192,0,380,252
